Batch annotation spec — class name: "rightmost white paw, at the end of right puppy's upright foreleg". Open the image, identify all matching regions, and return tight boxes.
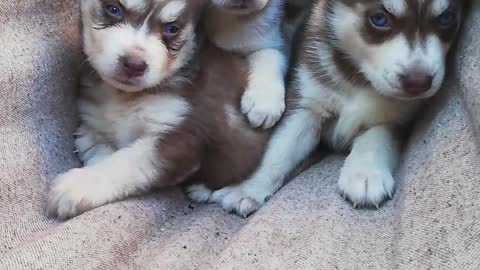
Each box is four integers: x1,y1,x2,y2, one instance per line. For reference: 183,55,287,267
338,165,394,208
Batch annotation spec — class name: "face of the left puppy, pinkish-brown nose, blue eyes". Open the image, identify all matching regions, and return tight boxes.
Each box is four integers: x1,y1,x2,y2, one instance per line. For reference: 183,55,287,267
81,0,201,92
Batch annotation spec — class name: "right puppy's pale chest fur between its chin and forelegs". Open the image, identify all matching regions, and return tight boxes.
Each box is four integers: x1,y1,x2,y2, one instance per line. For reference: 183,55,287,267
297,67,419,148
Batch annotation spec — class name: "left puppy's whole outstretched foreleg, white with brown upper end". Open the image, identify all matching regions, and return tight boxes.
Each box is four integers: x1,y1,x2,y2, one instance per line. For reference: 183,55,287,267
47,133,199,219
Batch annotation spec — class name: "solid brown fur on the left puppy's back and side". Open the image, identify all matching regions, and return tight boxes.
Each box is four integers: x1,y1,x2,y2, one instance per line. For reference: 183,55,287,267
154,44,269,188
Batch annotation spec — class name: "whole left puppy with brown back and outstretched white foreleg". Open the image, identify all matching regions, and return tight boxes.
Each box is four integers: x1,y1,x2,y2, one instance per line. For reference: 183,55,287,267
47,0,268,219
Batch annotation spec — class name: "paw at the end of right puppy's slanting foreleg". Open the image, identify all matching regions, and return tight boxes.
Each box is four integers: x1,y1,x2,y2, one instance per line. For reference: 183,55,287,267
210,186,269,218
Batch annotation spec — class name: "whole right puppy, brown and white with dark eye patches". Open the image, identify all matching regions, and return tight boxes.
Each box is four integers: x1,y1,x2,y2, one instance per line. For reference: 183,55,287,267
210,0,467,215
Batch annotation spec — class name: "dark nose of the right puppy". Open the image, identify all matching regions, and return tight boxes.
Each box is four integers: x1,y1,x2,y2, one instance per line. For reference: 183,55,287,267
399,68,433,96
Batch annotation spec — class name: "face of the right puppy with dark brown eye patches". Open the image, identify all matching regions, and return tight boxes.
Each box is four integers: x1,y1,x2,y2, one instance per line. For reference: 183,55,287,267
327,0,466,99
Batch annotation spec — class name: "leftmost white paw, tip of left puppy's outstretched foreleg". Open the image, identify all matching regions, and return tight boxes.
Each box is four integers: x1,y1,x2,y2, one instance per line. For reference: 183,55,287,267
47,168,108,220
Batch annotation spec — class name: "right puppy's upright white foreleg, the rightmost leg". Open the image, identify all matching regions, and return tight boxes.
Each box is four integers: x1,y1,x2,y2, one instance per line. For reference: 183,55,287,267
338,126,399,208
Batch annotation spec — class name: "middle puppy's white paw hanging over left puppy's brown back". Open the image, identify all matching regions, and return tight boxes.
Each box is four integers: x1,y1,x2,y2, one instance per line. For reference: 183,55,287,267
241,82,285,129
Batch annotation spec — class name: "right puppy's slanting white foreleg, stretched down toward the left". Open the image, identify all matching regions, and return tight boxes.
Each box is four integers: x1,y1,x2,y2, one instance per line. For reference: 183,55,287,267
210,110,321,217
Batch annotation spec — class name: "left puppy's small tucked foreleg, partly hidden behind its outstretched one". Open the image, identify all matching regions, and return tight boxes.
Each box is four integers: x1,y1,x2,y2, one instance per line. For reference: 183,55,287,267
74,124,115,166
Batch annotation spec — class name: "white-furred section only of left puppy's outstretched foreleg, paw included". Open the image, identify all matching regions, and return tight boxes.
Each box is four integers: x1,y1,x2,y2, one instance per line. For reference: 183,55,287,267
49,137,162,219
